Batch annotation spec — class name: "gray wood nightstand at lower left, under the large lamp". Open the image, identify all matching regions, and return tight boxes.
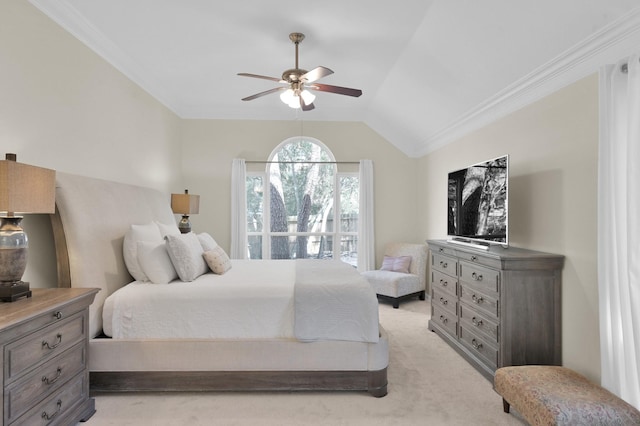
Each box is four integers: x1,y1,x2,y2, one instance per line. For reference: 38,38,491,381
0,288,98,425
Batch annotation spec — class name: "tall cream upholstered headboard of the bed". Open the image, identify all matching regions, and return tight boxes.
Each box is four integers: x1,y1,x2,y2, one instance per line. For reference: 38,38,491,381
51,172,175,337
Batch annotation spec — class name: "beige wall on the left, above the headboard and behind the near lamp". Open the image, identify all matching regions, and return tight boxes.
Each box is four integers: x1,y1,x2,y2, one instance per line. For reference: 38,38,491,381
0,0,181,287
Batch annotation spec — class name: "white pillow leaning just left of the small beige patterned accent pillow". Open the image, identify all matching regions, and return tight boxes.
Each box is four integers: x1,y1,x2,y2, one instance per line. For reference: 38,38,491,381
164,232,209,281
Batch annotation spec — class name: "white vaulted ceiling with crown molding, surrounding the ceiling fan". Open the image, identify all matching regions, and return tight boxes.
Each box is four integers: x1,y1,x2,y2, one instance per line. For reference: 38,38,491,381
30,0,640,157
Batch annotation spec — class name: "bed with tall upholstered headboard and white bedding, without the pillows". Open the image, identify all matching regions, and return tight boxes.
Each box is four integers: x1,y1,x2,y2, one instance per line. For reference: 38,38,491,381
52,173,389,397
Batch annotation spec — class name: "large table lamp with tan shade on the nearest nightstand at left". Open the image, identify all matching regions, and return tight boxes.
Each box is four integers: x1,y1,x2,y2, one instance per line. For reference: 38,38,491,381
0,154,56,302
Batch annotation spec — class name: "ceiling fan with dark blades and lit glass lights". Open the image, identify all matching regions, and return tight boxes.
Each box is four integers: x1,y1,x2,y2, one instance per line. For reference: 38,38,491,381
238,33,362,111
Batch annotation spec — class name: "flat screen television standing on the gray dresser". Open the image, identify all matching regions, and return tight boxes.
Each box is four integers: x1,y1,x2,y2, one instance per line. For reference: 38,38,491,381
447,155,509,248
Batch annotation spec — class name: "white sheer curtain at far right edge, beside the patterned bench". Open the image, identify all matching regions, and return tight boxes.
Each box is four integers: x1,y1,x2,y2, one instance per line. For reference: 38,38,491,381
598,55,640,408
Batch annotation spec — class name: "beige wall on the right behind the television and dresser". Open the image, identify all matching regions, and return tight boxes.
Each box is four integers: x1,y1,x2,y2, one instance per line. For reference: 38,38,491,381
419,75,600,380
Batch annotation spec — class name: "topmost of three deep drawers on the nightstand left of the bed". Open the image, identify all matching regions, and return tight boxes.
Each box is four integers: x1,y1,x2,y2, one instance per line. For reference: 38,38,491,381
4,312,86,386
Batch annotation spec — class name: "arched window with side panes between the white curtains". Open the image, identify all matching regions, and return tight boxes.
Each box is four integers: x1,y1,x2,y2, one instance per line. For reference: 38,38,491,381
246,137,359,266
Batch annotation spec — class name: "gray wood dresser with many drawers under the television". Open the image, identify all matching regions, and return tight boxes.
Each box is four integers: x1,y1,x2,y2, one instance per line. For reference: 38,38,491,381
427,240,564,380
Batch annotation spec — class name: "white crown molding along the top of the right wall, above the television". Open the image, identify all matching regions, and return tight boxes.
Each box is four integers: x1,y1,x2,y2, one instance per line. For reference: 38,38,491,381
416,7,640,156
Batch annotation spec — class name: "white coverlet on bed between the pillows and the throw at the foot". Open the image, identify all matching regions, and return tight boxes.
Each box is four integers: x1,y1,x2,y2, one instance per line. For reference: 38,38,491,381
103,260,295,339
